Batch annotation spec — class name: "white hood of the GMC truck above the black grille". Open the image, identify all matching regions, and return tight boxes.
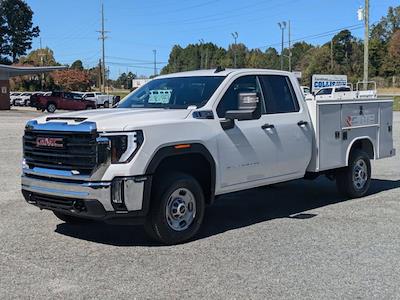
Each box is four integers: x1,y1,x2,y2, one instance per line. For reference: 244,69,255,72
38,108,191,131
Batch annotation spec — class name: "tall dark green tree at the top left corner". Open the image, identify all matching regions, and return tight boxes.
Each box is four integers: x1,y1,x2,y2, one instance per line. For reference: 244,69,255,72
0,0,40,62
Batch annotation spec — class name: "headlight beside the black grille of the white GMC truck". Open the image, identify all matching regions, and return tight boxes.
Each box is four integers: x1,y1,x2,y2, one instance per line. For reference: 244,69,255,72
106,130,143,164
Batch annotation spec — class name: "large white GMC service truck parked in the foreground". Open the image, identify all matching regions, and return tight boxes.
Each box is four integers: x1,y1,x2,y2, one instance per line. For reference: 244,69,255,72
22,68,395,244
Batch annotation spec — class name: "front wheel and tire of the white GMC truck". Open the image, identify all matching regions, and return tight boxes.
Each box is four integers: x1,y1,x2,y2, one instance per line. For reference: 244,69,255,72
145,173,205,245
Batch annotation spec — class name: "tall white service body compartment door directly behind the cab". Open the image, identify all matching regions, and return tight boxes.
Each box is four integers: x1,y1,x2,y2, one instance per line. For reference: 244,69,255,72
317,104,346,171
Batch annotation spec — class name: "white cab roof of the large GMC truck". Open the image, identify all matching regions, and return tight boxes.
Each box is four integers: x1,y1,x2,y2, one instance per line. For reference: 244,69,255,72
156,69,292,78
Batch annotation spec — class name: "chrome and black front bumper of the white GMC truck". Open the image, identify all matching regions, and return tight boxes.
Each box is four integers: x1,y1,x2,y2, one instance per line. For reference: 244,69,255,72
21,174,147,224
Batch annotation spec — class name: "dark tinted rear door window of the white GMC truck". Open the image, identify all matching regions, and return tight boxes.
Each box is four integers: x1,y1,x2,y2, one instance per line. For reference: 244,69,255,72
260,75,300,114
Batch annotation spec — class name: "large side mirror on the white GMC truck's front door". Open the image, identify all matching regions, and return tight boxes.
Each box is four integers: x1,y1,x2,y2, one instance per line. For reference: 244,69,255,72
221,93,261,129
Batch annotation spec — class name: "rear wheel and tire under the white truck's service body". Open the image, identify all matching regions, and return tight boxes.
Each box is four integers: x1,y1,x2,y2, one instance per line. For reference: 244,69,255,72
336,149,371,198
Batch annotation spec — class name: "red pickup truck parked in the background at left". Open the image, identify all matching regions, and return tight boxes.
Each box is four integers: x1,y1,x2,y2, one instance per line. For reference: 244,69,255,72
30,92,96,113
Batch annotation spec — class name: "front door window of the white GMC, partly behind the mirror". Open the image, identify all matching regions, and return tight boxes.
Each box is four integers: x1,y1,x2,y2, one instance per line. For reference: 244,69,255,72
217,76,261,118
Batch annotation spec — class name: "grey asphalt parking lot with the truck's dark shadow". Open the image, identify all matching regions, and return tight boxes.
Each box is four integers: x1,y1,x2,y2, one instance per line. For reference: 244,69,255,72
0,109,400,299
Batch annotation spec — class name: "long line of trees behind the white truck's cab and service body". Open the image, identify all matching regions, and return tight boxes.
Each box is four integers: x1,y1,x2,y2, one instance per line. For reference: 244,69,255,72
161,6,400,86
